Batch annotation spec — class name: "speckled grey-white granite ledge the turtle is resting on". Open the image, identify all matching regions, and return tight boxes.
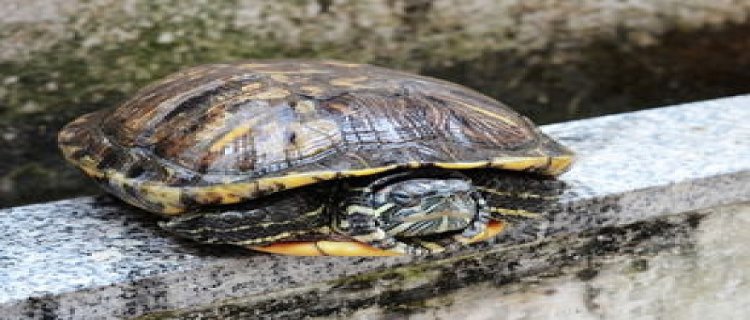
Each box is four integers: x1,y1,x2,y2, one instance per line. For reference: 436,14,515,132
0,96,750,319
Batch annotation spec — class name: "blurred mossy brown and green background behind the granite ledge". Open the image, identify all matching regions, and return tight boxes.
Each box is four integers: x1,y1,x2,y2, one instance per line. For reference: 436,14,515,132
0,0,750,207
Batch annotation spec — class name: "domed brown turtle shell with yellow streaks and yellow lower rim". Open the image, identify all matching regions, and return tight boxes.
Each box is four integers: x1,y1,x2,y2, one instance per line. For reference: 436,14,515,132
59,60,572,215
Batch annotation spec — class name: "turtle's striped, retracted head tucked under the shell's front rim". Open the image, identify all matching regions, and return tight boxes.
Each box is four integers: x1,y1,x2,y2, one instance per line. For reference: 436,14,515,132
334,172,496,254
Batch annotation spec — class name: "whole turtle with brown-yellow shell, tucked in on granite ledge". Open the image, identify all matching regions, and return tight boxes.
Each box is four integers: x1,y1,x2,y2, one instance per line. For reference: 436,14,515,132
58,60,574,256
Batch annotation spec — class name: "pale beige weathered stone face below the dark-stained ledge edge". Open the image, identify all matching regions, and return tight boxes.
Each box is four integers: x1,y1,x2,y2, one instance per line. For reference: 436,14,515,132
310,202,750,320
